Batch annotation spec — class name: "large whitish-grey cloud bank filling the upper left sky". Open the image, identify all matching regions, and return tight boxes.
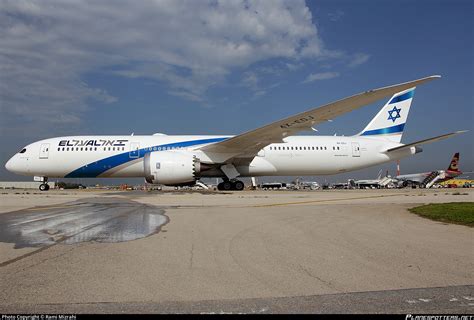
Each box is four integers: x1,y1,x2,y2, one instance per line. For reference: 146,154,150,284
0,0,348,129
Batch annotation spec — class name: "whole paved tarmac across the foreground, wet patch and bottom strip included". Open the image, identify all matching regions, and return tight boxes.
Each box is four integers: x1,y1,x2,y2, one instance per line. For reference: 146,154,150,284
0,189,474,313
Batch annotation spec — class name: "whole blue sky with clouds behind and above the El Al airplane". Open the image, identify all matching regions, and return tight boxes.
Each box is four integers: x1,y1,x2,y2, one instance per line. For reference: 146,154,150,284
0,0,474,182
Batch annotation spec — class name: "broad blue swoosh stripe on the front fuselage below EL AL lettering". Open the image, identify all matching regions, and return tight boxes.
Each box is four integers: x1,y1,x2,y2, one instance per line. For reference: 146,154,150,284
65,138,228,178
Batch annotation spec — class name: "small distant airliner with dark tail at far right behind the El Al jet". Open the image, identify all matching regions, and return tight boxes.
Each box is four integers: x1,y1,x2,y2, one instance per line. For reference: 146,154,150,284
395,152,462,188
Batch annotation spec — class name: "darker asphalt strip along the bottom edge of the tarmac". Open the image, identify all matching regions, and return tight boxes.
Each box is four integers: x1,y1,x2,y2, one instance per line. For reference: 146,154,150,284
3,286,474,314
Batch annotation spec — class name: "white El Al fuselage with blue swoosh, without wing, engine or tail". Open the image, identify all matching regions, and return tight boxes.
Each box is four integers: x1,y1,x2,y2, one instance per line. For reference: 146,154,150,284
6,135,416,178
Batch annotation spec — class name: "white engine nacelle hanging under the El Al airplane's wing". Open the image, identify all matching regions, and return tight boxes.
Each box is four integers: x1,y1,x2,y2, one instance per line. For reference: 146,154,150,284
143,151,201,185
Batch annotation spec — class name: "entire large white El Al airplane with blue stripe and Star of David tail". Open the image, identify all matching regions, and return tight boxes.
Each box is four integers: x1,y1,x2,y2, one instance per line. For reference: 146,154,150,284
5,76,464,191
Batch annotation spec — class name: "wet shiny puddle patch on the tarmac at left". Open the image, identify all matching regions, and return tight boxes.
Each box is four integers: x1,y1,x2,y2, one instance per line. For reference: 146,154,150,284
0,198,168,248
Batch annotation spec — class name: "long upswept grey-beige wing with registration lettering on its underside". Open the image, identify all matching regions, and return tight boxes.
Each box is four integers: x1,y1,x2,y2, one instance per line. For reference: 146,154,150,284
200,75,440,159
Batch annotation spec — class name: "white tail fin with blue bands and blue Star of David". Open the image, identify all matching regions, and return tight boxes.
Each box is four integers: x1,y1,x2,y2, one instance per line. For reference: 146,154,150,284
357,87,415,142
